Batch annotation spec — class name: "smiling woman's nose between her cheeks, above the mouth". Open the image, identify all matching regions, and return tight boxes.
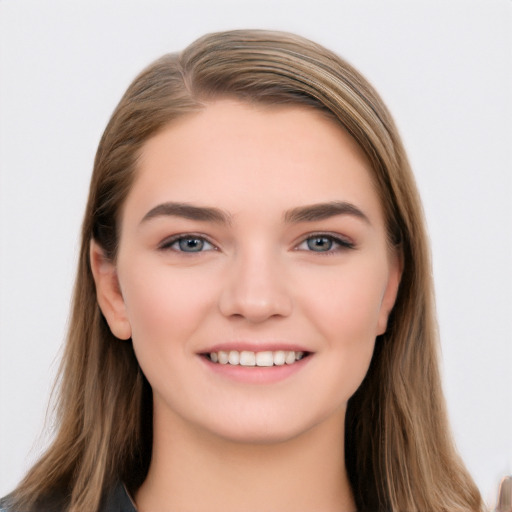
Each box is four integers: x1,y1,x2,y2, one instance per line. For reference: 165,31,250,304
219,248,293,323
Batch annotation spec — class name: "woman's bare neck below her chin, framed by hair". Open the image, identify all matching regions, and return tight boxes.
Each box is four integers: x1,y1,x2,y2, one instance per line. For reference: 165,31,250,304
135,411,355,512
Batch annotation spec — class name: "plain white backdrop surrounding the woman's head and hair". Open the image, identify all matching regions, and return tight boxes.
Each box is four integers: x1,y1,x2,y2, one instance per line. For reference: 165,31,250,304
0,0,512,508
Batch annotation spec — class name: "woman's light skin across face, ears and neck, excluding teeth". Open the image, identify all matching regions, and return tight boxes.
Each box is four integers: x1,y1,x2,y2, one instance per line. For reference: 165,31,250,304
91,100,401,512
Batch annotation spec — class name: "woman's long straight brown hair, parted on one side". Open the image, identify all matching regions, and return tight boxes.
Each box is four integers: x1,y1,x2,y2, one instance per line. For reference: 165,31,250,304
5,31,483,512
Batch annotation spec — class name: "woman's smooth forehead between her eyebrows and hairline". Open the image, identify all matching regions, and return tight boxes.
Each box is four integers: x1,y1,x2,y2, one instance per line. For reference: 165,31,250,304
125,100,380,226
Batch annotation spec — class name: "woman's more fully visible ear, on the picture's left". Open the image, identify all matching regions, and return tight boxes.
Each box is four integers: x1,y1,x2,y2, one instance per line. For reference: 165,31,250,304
89,240,132,340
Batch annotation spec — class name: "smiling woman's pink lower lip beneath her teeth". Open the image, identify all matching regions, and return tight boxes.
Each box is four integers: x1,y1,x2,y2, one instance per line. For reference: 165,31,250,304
200,354,312,384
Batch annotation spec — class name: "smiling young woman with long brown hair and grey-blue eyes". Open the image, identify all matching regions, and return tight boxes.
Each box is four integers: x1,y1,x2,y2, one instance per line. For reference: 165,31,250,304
4,31,483,512
